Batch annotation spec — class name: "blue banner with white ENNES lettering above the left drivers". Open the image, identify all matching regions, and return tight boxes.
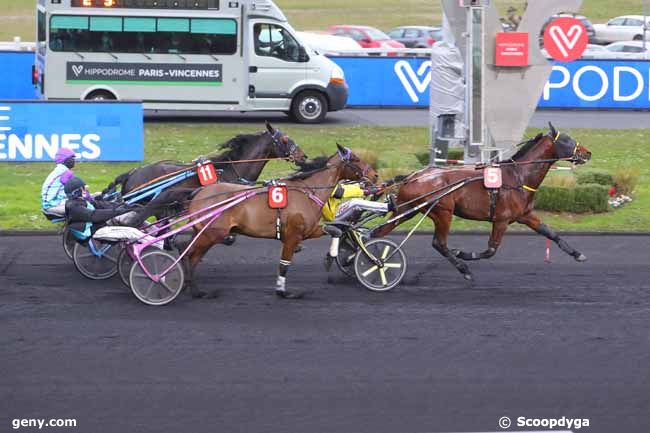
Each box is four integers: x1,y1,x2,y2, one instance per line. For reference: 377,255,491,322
0,101,144,162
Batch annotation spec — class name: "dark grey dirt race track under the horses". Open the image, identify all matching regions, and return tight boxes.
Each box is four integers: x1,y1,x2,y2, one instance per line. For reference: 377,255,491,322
0,235,650,433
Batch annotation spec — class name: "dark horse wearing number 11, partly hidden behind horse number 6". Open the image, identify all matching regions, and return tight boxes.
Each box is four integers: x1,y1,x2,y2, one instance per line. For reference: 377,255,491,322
102,122,307,195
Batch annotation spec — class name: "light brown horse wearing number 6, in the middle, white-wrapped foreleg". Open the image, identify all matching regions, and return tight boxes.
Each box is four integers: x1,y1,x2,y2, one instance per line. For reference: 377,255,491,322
188,145,377,299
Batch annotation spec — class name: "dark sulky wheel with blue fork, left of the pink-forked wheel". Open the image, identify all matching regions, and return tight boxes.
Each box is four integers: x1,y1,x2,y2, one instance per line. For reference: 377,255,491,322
72,239,121,280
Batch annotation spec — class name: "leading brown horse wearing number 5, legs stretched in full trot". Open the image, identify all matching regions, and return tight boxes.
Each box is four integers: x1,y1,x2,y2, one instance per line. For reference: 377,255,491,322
373,123,591,280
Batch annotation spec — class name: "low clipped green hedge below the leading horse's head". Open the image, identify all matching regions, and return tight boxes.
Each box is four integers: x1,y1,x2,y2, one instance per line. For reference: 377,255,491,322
535,183,608,213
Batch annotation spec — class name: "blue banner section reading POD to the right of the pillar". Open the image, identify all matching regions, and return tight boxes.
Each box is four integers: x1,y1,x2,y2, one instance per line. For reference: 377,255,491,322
539,60,650,109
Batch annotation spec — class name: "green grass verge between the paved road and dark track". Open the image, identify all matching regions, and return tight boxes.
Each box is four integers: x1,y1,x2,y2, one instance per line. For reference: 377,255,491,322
0,124,650,231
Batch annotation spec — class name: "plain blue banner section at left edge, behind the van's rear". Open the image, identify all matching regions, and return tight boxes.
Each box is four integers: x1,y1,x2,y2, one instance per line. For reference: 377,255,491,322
0,51,39,99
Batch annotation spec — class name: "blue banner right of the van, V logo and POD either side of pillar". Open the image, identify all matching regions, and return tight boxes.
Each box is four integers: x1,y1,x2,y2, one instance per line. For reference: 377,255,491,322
332,57,650,109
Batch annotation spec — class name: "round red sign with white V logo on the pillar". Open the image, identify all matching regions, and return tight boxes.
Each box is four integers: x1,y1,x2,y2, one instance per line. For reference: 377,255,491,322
544,17,589,62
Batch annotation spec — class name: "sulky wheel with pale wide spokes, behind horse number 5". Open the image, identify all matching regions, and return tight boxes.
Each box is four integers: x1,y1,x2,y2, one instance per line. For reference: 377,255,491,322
354,239,406,292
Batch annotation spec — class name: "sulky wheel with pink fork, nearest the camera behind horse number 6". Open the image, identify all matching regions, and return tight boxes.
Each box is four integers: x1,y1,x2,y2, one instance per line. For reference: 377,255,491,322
129,250,185,305
